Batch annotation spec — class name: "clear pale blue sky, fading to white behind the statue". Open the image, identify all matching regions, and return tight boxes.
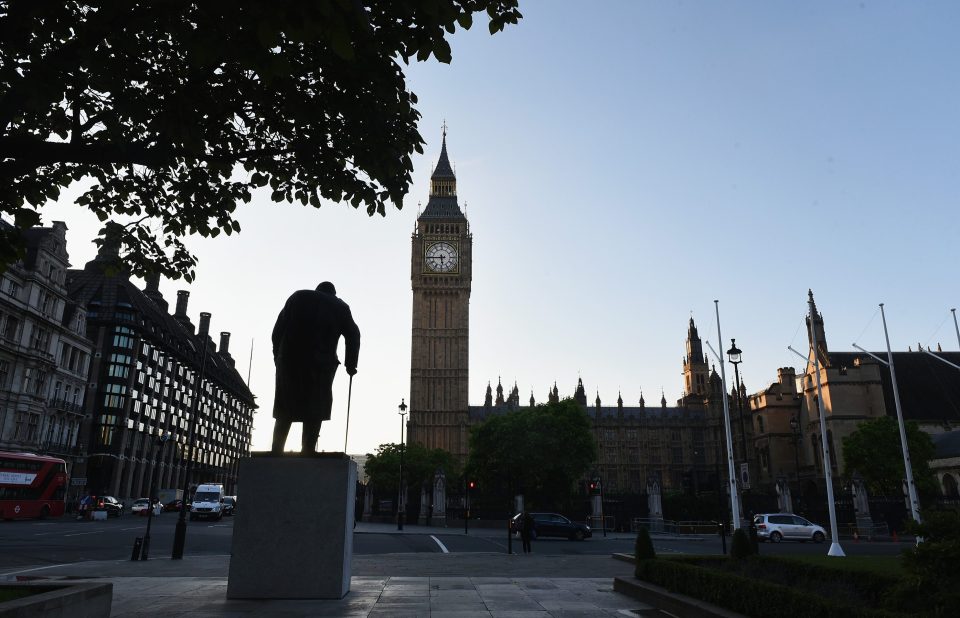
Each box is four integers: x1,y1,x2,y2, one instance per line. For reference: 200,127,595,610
42,0,960,454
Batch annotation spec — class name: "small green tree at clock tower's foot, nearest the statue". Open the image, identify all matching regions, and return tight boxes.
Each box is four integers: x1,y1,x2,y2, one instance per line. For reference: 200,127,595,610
364,443,461,495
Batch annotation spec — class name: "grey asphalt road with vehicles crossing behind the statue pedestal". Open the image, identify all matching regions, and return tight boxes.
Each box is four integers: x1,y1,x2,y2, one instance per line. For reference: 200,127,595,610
0,513,909,574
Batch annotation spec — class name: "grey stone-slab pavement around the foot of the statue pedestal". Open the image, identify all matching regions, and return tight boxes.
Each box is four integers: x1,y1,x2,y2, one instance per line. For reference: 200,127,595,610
0,523,666,618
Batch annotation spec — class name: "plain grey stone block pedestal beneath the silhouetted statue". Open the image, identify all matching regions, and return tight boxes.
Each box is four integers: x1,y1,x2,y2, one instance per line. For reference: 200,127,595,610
227,453,357,599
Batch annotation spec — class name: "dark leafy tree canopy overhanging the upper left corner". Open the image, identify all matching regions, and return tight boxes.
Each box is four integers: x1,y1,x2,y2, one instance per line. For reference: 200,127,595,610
0,0,521,280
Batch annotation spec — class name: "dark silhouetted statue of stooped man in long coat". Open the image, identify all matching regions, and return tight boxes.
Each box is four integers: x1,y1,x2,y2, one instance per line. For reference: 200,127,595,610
272,281,360,455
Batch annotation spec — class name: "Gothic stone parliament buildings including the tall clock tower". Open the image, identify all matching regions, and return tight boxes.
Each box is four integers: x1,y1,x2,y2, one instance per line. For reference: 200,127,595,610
408,129,960,494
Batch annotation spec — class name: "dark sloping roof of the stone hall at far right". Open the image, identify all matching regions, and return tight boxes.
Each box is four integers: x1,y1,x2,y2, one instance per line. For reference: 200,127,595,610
830,352,960,425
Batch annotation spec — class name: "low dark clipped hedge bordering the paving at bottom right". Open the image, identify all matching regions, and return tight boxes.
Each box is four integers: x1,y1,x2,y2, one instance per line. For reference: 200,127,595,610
636,556,906,618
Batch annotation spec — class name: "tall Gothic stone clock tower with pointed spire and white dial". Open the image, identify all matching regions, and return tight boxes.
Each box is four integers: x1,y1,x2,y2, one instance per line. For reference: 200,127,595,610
408,126,473,459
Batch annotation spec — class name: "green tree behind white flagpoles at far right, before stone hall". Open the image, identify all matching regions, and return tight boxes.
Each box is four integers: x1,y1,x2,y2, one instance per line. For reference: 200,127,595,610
843,416,937,496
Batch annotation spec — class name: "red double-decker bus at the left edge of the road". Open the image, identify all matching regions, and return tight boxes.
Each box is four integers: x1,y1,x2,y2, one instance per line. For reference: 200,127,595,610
0,451,67,519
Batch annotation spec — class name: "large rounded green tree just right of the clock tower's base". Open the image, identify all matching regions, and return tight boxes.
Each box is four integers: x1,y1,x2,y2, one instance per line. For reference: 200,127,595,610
467,399,597,508
